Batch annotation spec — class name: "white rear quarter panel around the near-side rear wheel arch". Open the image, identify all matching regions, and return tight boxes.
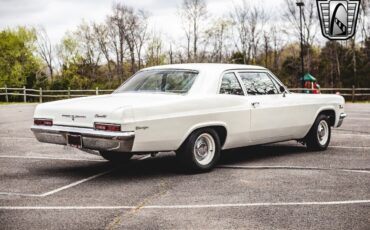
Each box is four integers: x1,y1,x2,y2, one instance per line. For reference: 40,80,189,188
127,95,250,152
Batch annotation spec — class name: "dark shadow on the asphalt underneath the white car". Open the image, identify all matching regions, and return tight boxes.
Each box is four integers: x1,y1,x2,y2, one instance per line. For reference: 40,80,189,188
37,145,307,180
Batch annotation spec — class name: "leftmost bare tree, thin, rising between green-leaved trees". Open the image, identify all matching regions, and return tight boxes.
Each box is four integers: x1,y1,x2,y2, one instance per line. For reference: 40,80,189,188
36,27,54,80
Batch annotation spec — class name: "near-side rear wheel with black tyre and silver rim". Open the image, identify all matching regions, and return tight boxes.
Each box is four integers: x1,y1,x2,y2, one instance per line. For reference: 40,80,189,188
176,128,221,172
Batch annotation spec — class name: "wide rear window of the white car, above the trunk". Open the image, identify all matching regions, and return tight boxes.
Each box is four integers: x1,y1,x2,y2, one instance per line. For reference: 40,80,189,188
114,70,198,94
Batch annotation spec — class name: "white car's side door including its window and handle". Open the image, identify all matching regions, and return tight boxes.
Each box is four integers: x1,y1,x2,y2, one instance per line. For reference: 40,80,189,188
238,71,296,144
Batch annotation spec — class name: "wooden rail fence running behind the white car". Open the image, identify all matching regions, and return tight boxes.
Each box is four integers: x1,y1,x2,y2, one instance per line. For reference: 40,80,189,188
0,86,370,103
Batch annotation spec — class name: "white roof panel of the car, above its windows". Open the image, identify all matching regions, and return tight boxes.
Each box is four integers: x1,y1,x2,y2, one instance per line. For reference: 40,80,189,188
143,63,266,72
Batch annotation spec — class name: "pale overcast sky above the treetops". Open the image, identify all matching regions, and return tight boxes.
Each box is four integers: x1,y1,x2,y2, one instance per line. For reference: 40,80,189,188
0,0,284,43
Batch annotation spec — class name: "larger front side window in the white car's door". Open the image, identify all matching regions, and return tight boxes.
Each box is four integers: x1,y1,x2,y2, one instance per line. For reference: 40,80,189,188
239,72,279,95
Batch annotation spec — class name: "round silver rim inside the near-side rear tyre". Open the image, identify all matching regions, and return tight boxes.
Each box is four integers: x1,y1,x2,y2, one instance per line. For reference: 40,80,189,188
193,133,216,165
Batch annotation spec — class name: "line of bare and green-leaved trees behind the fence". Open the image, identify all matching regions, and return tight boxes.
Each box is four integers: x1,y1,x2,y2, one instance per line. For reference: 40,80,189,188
0,0,370,89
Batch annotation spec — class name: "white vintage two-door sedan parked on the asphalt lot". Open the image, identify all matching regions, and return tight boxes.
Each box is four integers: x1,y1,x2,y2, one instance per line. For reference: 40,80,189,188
31,64,346,171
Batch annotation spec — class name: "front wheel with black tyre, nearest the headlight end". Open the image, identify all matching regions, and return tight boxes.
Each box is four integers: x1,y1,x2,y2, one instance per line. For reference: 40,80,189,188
306,114,331,151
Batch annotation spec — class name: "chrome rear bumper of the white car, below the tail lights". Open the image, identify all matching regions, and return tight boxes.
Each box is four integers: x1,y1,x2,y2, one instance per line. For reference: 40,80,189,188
31,125,135,152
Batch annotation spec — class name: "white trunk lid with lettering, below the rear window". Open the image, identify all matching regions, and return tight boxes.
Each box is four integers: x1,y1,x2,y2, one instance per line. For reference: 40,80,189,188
34,93,182,128
